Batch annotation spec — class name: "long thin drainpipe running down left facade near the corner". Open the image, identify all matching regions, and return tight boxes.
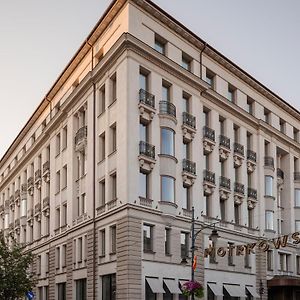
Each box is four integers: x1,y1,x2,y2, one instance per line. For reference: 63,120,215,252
86,41,96,300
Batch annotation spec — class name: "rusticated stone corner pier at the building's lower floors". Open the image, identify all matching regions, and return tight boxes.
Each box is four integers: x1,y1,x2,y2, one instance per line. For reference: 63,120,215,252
117,216,142,300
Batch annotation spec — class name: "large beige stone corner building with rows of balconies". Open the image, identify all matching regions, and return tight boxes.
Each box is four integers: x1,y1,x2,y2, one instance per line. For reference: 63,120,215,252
0,0,300,300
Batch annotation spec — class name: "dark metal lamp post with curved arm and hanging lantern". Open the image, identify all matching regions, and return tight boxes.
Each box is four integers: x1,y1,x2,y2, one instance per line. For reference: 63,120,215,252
191,206,219,300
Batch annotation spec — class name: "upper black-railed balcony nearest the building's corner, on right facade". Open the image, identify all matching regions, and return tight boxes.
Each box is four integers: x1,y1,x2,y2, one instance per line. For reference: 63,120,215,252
138,89,156,123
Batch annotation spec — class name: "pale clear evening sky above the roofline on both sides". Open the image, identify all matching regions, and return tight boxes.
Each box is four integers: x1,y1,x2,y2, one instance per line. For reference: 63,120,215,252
0,0,300,158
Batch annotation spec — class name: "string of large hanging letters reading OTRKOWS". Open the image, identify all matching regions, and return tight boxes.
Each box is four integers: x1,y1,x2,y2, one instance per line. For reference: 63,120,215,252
204,232,300,257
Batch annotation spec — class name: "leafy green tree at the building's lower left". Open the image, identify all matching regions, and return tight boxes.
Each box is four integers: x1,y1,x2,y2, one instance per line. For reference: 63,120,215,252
0,231,35,300
